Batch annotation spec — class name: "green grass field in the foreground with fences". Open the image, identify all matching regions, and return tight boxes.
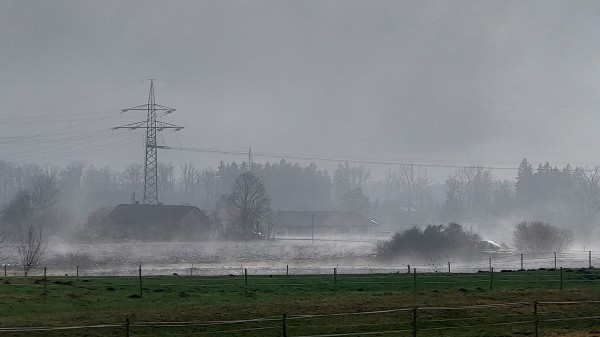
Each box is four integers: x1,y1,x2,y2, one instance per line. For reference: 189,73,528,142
0,269,600,337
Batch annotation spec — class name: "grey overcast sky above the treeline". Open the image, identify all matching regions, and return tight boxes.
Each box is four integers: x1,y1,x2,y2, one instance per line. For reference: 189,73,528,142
0,0,600,181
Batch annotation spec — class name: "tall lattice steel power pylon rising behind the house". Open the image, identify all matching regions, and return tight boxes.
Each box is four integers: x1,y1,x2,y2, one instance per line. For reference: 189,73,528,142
113,79,183,205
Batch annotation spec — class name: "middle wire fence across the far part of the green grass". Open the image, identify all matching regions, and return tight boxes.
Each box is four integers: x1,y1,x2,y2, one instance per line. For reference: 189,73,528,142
3,266,600,297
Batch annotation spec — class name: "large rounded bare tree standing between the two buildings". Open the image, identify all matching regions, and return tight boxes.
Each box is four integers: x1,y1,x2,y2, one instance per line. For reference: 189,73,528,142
230,172,271,240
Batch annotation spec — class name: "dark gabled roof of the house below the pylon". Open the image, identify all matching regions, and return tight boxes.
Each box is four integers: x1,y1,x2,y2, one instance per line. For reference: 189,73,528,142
110,204,210,224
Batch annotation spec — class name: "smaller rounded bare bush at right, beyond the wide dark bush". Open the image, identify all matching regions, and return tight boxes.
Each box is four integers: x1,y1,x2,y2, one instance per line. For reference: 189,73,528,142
513,221,573,253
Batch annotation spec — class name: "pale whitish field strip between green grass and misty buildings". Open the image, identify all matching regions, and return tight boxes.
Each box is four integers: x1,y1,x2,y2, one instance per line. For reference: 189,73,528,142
2,238,600,276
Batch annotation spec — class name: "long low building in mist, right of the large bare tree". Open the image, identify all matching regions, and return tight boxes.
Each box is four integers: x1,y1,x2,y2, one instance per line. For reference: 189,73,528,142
272,211,379,239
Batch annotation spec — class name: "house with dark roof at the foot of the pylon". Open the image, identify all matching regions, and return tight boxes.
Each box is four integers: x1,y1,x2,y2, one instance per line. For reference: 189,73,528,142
109,204,212,241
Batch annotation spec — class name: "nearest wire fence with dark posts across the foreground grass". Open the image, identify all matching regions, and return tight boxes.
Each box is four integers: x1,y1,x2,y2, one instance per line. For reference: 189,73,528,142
0,301,600,337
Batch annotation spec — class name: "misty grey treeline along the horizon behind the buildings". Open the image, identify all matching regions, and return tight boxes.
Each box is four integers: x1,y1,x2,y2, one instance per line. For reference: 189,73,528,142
0,159,600,238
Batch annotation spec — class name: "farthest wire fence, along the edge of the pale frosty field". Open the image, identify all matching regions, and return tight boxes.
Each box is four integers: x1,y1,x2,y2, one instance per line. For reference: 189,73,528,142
0,247,600,276
